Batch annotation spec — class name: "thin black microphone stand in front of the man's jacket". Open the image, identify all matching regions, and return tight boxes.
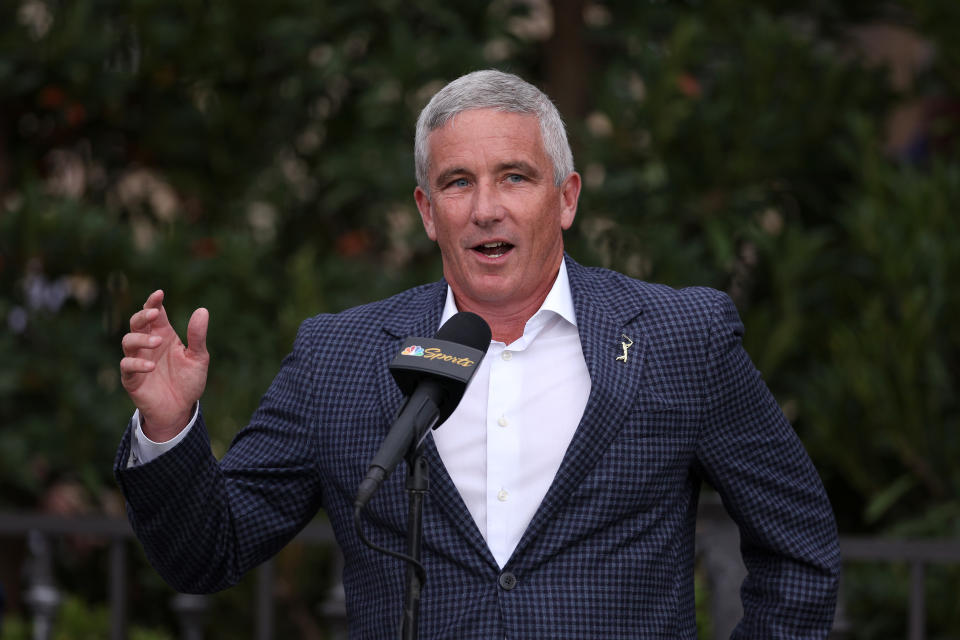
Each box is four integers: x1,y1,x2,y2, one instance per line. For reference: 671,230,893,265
400,450,430,640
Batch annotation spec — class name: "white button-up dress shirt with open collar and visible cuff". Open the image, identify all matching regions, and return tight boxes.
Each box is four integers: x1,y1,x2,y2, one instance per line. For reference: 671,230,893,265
129,263,590,567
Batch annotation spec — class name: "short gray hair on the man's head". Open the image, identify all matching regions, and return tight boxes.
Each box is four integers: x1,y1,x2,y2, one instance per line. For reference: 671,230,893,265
413,69,573,195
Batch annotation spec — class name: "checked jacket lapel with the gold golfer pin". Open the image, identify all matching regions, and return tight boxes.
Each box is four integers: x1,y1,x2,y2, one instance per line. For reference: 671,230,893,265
510,256,646,564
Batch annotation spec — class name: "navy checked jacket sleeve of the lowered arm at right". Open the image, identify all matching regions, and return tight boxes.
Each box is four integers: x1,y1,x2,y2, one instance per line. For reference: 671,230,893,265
697,294,840,639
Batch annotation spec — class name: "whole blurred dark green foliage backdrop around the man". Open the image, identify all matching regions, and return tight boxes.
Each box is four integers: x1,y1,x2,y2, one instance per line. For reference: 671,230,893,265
0,0,960,640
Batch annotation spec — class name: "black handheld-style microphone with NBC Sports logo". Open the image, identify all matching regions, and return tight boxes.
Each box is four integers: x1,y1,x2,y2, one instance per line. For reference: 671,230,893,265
353,311,490,510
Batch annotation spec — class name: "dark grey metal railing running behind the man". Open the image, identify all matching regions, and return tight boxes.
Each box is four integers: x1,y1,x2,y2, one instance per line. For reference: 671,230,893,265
0,504,960,640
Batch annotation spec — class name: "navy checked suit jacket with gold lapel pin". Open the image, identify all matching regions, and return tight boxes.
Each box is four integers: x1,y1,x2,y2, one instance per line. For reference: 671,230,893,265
116,257,839,640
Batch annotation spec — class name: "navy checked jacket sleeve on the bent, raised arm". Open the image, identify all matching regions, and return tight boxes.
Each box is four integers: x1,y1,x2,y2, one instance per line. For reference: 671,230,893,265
114,321,322,593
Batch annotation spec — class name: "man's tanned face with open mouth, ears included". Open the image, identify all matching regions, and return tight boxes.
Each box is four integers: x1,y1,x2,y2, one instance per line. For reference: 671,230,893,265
414,109,580,315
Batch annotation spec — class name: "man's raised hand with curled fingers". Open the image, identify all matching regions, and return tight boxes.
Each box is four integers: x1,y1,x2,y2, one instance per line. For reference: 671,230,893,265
120,290,210,442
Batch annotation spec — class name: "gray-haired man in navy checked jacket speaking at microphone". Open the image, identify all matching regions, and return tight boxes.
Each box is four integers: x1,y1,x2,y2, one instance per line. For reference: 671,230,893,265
116,71,839,639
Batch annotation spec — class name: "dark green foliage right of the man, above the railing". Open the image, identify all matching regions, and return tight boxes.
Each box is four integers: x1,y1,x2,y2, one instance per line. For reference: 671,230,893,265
573,3,960,535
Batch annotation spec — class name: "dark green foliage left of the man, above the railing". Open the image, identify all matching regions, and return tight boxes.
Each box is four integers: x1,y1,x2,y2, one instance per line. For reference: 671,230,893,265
0,0,536,507
